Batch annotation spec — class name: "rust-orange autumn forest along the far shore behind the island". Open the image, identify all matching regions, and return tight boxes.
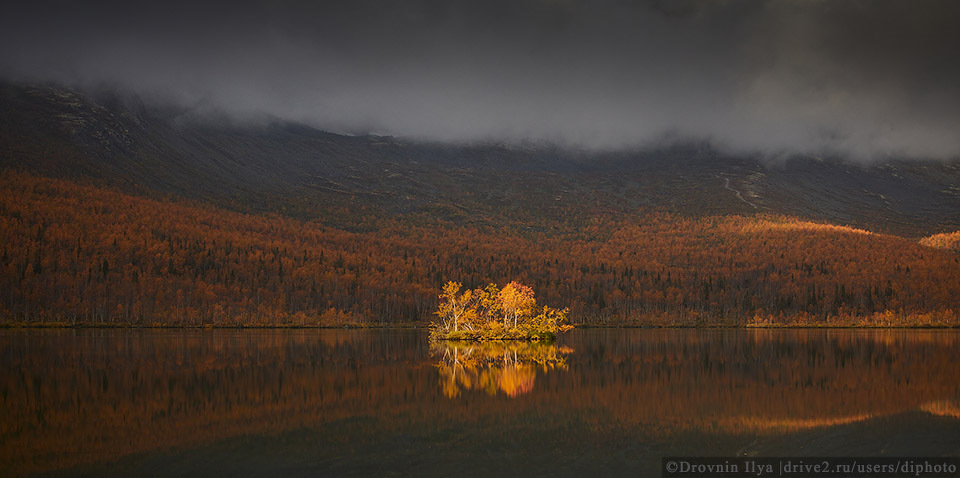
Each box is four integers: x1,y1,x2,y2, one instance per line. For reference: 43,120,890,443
0,170,960,331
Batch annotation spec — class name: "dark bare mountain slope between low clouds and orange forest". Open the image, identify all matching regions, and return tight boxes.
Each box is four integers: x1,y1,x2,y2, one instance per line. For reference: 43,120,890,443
0,83,960,237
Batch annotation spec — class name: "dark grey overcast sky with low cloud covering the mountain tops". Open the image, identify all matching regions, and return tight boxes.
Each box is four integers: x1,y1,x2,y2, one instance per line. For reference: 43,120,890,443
0,0,960,158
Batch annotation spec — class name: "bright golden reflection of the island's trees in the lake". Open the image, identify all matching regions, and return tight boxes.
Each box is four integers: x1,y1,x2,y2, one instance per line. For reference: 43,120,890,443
430,340,573,398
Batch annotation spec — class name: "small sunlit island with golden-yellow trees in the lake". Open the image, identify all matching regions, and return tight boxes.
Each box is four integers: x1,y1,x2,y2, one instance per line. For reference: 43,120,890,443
430,281,573,341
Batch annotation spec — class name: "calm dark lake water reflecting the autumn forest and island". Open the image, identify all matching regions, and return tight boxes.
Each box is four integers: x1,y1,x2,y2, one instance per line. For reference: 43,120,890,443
0,329,960,477
